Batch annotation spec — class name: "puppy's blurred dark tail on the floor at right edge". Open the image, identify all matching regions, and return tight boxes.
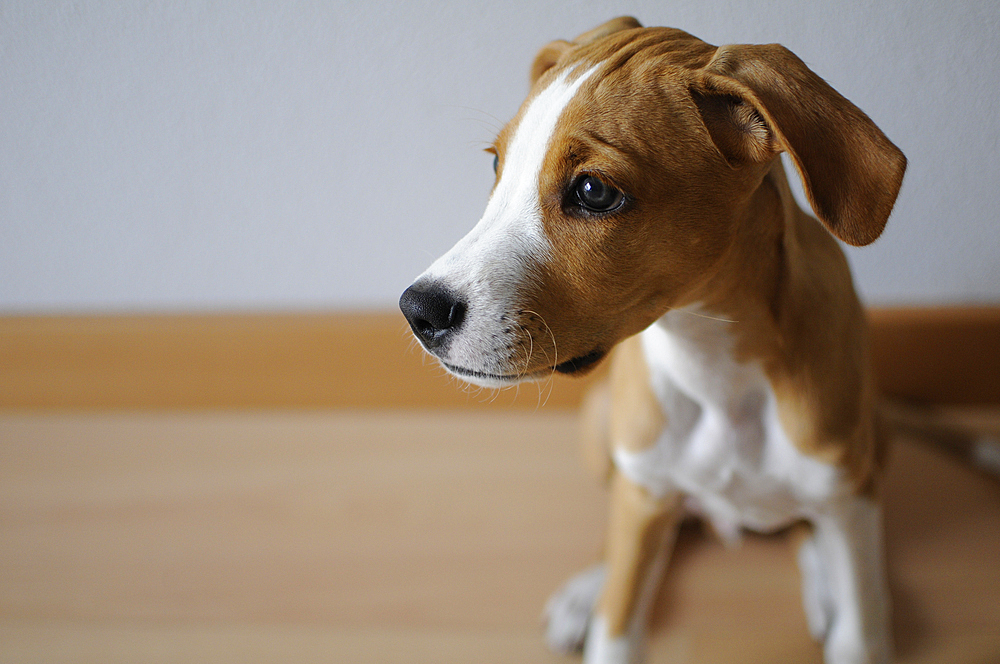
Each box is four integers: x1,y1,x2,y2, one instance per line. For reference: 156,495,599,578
879,400,1000,478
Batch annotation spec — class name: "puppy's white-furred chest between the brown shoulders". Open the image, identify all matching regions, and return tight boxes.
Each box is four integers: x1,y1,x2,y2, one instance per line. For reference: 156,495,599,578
614,311,841,534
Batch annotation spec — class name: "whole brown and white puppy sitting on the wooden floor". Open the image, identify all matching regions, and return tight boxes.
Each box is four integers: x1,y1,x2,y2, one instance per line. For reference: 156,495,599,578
400,18,906,664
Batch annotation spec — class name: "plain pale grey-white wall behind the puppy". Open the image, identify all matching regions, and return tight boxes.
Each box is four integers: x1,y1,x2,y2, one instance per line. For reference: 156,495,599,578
0,0,1000,313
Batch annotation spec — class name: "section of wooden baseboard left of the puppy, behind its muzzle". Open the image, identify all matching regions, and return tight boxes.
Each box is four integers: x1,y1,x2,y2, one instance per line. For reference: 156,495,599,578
0,313,582,410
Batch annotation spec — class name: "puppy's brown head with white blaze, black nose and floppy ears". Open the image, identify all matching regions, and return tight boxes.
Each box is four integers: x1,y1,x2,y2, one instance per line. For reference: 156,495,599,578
400,18,905,387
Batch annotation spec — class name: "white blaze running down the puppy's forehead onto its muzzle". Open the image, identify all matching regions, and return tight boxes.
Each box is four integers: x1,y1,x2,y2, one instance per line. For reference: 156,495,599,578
418,67,596,384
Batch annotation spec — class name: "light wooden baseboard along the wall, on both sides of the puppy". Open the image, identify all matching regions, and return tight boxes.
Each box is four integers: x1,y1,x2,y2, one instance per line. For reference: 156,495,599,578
0,307,1000,410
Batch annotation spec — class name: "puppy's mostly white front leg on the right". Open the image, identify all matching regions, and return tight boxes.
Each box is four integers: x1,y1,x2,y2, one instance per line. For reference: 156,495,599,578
799,496,892,664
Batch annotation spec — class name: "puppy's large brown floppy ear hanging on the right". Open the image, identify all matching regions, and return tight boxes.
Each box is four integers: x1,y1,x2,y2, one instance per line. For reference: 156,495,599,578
691,44,906,246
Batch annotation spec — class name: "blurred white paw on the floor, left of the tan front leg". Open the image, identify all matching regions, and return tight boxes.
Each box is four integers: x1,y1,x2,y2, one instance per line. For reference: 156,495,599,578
544,565,606,654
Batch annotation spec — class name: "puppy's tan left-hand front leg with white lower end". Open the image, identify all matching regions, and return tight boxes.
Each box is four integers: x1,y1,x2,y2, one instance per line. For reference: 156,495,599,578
584,473,681,664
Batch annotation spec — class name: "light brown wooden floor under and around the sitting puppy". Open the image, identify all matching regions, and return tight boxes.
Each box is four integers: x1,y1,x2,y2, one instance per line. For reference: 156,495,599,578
0,411,1000,664
